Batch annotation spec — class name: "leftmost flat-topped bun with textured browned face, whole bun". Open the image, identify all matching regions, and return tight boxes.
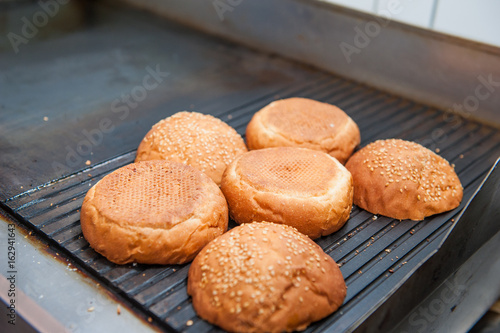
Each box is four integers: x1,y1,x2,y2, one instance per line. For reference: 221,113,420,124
80,161,228,264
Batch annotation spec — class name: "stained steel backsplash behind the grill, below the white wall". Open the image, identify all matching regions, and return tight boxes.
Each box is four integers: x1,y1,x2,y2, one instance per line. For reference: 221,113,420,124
122,0,500,126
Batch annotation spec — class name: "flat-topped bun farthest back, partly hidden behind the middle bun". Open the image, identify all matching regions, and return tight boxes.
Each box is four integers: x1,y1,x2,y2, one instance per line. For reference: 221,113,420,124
246,98,361,164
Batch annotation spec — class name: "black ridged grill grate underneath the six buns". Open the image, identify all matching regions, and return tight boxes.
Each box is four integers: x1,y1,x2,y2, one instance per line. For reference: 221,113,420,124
6,75,500,332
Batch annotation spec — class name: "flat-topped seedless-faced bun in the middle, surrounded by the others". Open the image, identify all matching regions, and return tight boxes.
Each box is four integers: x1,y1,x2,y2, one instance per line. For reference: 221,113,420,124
221,147,353,239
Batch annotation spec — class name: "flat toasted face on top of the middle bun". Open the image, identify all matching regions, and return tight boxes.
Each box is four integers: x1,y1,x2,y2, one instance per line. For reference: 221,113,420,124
236,147,343,196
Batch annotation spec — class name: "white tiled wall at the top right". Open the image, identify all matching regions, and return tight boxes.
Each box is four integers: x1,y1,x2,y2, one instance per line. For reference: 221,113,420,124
323,0,500,46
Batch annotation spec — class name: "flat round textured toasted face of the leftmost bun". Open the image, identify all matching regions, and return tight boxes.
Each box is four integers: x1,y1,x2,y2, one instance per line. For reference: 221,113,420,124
94,161,207,228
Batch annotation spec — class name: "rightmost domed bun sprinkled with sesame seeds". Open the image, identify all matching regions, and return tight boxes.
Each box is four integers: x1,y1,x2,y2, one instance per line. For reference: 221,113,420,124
346,139,463,221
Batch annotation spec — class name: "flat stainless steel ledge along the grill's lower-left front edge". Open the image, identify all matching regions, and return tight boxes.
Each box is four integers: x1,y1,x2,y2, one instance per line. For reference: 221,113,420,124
0,216,156,333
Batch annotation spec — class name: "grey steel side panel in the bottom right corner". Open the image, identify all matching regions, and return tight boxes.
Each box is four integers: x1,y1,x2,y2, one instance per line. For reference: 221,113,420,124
392,228,500,333
